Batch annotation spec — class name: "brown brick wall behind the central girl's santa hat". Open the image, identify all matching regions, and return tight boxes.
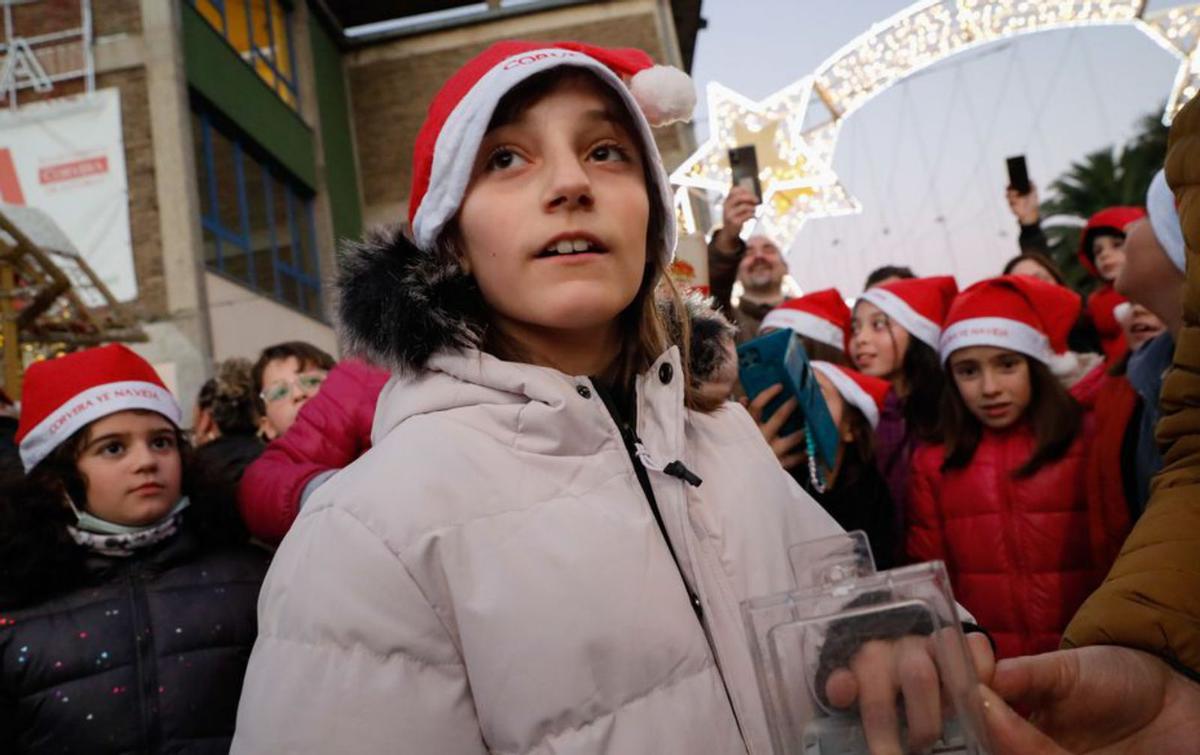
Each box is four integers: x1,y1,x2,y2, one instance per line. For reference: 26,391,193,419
348,8,686,220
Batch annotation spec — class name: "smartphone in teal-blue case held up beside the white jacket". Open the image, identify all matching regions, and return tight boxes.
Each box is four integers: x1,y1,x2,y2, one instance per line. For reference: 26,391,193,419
738,328,838,469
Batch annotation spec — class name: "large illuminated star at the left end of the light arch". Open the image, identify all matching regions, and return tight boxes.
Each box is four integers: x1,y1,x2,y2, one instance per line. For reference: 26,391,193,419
671,77,862,248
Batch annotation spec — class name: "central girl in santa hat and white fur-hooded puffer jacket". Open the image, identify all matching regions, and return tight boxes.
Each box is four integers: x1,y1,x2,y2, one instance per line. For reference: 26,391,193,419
234,41,988,754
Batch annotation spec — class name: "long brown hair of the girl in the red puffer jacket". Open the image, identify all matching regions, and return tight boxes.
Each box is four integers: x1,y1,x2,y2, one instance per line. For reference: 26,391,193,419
942,354,1082,479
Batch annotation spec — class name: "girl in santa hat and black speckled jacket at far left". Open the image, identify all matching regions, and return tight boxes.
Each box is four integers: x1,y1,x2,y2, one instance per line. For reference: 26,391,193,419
0,346,269,753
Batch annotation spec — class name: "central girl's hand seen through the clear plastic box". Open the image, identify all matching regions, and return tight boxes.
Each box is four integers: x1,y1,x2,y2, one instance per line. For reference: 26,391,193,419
826,630,996,755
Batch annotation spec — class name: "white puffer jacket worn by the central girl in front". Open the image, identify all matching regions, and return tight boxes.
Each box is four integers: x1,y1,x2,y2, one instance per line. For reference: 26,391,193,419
233,231,839,755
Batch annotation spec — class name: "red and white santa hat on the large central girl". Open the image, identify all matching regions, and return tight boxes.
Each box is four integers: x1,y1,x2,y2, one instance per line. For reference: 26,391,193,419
408,40,696,262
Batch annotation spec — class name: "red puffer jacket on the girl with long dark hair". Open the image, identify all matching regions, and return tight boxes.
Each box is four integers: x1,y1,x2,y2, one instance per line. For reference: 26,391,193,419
906,423,1103,658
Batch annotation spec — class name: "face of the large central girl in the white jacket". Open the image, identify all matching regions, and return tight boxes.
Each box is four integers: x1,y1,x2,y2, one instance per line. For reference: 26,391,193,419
458,77,649,341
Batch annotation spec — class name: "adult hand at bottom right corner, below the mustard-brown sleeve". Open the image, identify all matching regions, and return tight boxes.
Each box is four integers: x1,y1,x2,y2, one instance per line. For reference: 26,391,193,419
982,646,1200,755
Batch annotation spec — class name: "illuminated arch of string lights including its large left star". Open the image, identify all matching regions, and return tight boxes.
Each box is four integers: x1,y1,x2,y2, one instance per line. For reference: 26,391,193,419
671,0,1200,246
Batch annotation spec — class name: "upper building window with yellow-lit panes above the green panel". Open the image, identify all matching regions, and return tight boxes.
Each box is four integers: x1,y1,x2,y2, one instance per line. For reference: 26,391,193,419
191,0,298,109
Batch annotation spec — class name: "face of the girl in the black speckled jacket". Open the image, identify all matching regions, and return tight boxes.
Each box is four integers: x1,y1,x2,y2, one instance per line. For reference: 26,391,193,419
76,411,184,526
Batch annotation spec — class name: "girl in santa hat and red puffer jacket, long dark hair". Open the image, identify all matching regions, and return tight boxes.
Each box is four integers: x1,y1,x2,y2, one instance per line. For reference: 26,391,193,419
906,276,1103,657
